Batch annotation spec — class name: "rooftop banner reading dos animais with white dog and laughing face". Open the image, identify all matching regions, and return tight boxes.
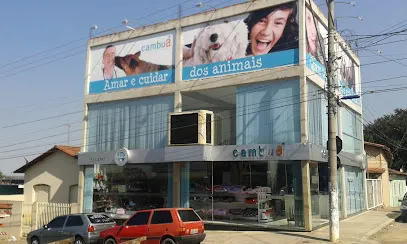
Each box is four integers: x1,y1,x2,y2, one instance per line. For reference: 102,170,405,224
182,2,298,80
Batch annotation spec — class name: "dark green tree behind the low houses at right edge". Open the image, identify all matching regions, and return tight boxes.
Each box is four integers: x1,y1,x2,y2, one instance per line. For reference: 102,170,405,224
363,109,407,170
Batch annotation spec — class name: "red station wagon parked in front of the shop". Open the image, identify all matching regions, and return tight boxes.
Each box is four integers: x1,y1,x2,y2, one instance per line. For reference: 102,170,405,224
99,208,206,244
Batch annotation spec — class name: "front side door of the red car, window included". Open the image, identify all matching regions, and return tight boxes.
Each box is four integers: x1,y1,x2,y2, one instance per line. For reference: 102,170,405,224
117,211,151,241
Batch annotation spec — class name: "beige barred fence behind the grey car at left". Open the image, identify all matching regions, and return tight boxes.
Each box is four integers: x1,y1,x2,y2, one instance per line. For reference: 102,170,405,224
22,202,73,235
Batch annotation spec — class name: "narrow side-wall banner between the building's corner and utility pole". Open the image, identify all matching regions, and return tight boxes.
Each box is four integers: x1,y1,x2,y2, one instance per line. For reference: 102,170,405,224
305,8,328,80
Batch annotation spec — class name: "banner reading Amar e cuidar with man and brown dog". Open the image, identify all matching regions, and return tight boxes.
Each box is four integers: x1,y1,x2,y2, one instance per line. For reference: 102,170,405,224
88,31,175,94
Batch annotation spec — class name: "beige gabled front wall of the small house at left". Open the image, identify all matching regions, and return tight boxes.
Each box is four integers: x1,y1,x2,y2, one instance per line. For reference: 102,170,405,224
24,151,79,203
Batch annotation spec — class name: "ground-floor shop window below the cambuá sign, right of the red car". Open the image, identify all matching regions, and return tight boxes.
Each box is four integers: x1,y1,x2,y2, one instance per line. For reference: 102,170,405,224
189,161,304,229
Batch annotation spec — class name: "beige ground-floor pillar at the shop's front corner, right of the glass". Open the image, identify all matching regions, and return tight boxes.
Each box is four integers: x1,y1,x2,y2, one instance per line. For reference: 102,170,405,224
301,161,312,231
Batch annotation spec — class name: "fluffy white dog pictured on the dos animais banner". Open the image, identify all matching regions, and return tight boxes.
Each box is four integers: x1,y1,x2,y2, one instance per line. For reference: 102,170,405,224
184,21,249,66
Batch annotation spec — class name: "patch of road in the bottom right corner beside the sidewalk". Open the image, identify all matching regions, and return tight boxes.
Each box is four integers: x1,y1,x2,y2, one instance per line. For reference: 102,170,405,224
371,220,407,244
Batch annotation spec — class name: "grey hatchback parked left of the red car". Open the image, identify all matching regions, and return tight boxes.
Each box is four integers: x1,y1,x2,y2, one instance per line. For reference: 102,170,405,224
27,213,116,244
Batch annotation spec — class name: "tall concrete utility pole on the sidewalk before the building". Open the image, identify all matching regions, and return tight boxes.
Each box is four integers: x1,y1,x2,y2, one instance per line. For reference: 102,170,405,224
327,0,339,242
